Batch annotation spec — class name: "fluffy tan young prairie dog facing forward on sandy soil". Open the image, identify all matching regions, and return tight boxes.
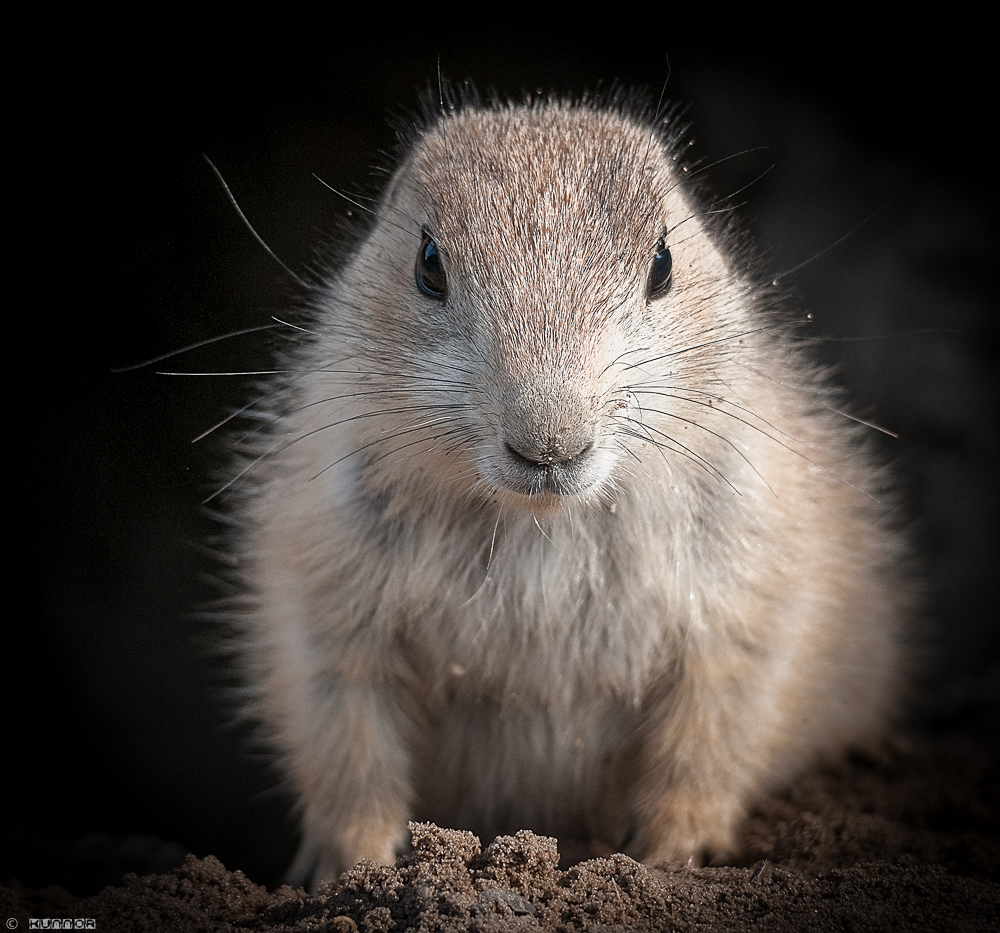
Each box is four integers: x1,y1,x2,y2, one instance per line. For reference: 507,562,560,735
230,94,910,884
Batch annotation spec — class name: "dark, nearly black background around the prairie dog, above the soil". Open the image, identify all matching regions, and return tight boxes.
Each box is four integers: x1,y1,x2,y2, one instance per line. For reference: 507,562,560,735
11,27,998,893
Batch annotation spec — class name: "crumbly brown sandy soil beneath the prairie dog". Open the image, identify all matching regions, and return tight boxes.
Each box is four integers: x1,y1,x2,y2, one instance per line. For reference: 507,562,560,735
0,676,1000,933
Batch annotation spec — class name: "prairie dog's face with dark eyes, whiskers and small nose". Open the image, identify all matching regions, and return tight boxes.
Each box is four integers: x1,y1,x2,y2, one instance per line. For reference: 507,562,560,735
344,108,744,511
